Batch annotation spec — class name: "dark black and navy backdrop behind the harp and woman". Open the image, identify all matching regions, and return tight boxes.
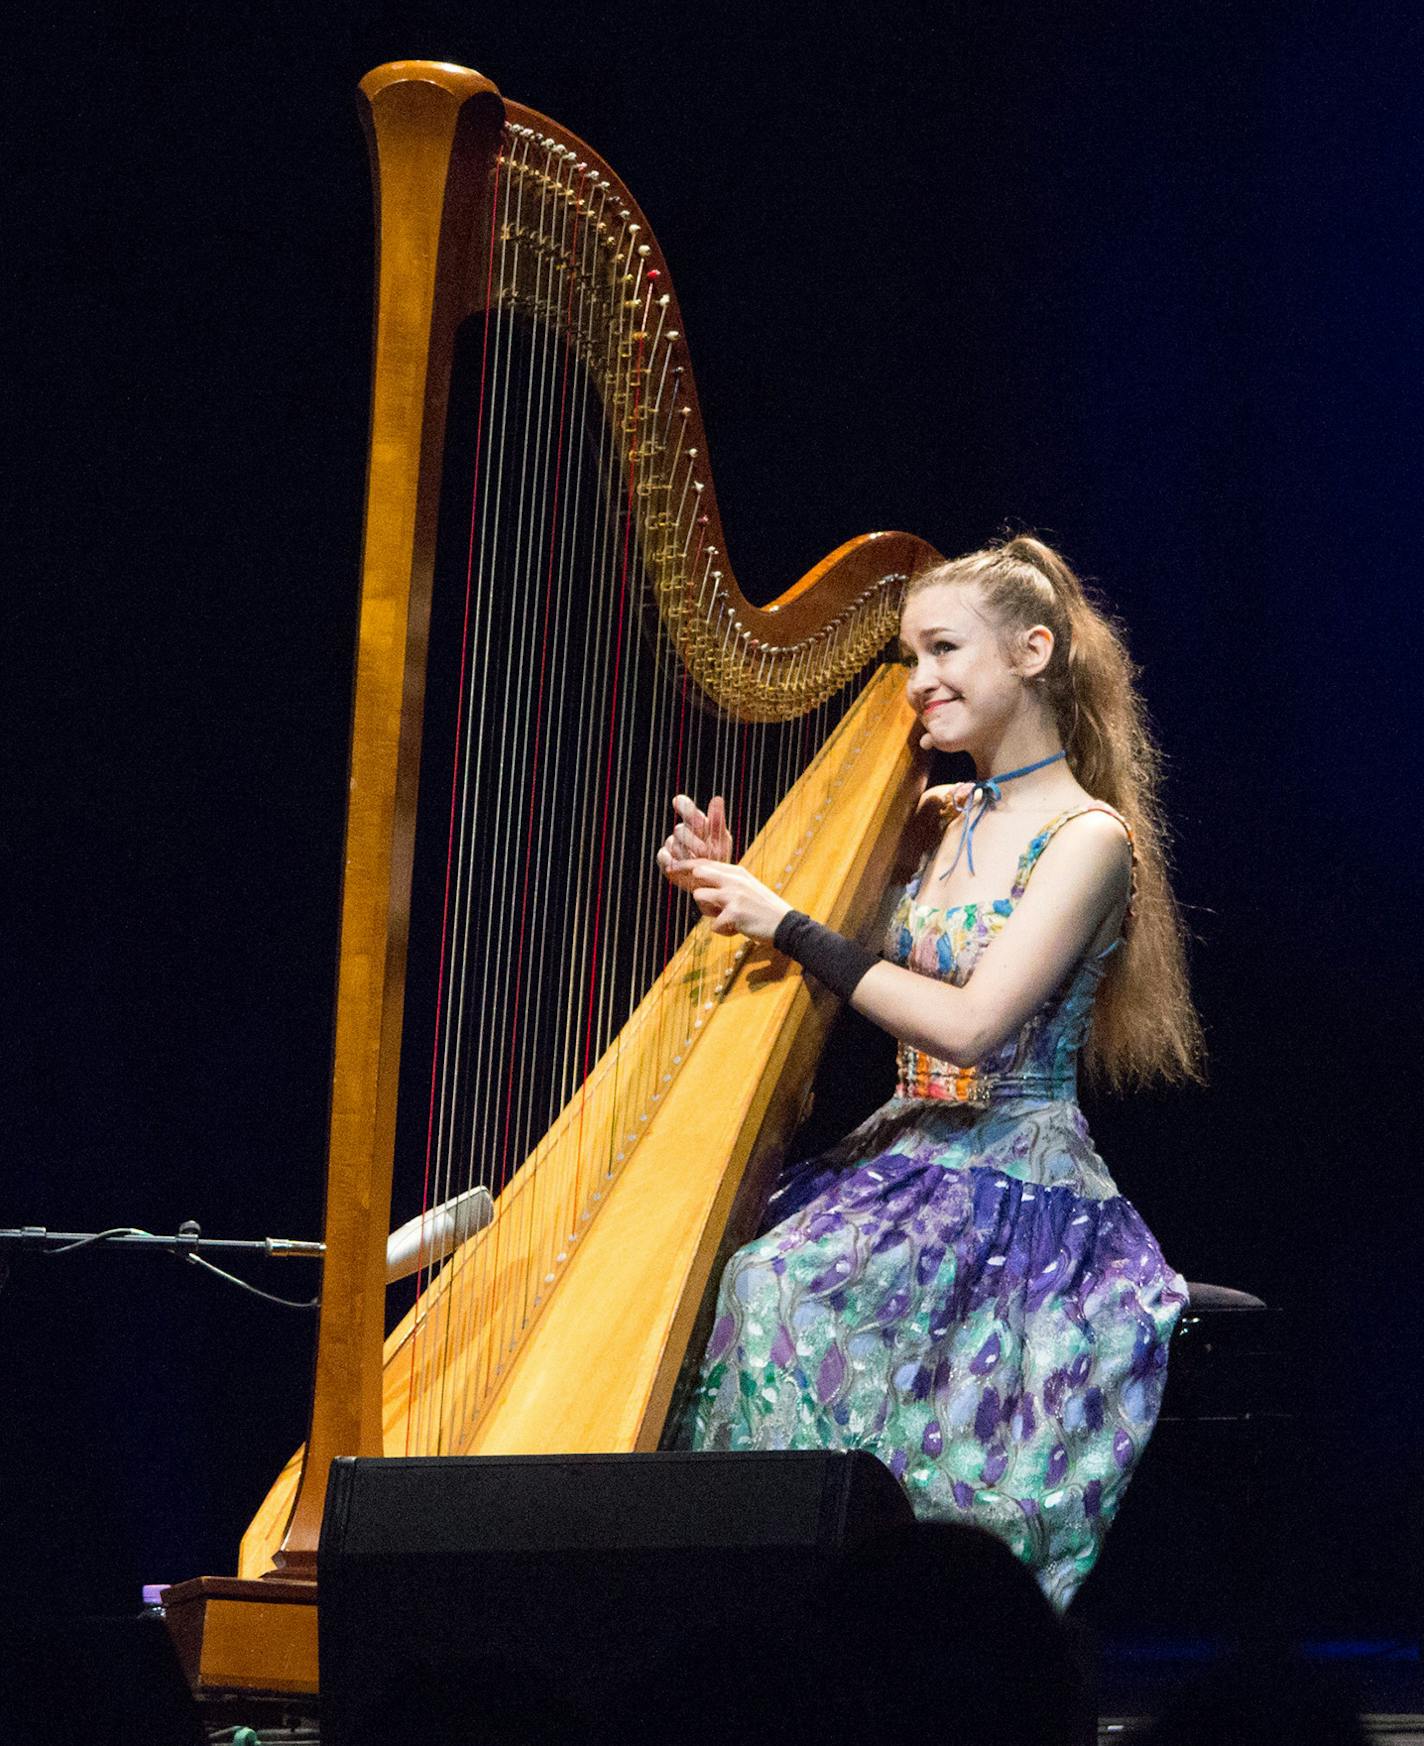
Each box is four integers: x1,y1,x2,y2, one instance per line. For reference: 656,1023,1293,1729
0,0,1424,1626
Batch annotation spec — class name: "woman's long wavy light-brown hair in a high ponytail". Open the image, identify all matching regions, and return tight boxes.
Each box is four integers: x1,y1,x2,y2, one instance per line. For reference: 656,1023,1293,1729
906,534,1204,1090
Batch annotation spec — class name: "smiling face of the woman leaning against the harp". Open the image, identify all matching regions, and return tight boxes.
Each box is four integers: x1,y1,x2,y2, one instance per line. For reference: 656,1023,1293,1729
900,583,1023,753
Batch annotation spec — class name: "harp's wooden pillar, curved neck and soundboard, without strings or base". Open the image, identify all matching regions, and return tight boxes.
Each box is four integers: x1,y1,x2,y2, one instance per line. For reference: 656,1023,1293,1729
241,61,939,1575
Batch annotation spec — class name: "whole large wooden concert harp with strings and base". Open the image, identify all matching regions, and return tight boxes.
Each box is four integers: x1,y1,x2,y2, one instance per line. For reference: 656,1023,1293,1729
168,61,935,1692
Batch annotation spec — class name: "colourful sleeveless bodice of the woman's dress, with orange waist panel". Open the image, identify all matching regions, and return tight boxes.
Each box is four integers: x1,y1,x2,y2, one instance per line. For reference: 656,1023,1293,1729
883,801,1136,1107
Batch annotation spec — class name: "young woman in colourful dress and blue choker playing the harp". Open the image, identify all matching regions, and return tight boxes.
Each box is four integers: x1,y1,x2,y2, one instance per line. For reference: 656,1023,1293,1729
658,536,1201,1606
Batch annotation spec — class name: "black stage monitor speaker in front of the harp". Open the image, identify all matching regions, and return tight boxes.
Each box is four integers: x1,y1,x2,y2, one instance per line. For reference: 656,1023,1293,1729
318,1451,913,1746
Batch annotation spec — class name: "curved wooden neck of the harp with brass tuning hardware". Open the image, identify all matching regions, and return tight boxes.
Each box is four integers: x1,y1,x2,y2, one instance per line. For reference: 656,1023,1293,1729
361,61,939,680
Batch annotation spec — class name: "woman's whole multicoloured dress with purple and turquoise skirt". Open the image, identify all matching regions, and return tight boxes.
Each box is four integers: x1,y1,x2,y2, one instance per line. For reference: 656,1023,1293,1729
688,801,1187,1606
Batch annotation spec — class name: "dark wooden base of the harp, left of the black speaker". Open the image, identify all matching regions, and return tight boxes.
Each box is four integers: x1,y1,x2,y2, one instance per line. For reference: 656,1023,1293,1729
164,1577,316,1697
